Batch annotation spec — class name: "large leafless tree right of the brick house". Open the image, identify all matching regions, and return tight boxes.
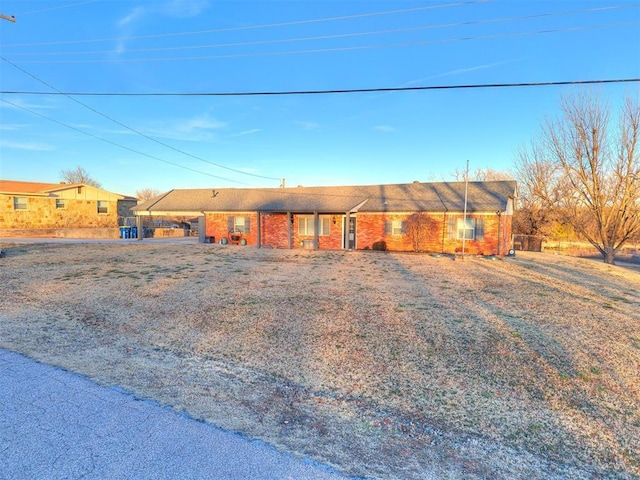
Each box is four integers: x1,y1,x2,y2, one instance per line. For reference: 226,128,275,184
516,94,640,264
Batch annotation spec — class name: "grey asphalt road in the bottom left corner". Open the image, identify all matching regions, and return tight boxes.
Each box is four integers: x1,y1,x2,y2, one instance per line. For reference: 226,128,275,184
0,349,344,480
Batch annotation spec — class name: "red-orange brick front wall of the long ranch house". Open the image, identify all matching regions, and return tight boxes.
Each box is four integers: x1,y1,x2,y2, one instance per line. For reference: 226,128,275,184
205,212,511,255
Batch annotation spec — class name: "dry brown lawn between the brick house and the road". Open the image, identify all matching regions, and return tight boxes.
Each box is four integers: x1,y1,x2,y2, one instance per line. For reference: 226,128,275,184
0,244,640,480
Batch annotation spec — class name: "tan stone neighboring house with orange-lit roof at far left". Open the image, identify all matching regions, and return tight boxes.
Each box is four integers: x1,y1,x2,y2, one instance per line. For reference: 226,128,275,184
0,180,137,236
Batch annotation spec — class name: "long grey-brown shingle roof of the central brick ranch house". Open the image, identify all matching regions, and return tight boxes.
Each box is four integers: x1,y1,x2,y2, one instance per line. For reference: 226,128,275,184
133,180,516,213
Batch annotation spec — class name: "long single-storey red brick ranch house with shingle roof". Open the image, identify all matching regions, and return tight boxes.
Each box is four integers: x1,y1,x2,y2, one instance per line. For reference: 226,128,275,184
133,181,516,255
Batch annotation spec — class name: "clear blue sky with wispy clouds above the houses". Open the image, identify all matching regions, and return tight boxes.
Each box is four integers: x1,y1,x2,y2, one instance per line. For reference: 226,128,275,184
0,0,640,195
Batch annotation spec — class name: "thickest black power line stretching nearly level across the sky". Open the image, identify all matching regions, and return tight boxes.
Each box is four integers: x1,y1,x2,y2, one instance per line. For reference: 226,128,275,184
0,78,640,97
